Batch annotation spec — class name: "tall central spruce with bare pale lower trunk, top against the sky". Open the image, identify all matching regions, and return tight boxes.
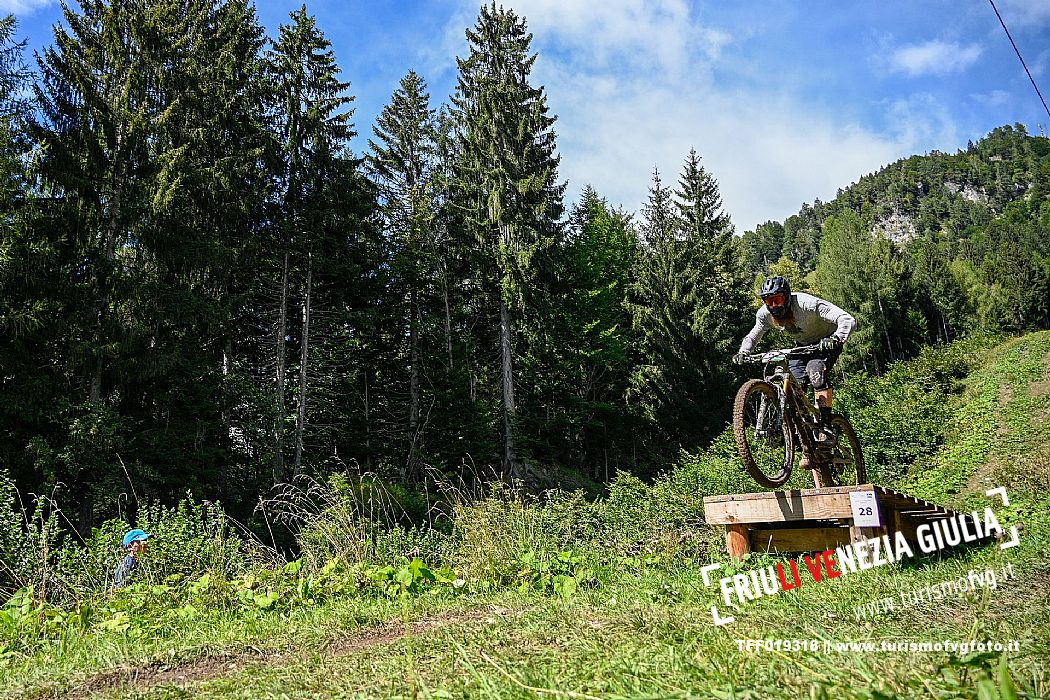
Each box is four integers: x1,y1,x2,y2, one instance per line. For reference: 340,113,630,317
453,2,564,479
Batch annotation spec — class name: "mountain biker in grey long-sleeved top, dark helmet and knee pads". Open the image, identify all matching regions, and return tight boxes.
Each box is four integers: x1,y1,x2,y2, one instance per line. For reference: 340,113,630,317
733,275,857,459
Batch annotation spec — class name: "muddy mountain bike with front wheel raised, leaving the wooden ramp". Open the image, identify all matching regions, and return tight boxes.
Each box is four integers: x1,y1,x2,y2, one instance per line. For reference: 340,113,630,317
733,345,867,488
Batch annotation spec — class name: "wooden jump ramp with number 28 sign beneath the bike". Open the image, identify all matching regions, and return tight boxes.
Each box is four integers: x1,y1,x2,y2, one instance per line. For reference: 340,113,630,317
704,484,966,557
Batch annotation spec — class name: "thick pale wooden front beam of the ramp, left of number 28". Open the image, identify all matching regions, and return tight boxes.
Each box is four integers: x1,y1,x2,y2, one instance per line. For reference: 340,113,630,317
704,487,853,525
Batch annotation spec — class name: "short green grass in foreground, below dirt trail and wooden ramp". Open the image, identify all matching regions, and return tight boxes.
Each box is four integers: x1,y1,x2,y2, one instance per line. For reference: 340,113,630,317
94,553,1050,698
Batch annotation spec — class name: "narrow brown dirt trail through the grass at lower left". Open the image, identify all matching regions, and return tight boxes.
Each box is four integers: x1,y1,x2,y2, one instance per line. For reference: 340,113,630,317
30,607,516,700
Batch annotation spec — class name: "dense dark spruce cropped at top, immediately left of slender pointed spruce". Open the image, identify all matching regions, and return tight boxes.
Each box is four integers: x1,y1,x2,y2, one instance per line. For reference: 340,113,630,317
135,0,269,505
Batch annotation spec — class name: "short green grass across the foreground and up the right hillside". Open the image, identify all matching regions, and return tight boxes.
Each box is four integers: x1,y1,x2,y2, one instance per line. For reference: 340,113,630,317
8,333,1050,698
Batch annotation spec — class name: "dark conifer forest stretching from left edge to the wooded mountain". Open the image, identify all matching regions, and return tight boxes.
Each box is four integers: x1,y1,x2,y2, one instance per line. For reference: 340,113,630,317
0,0,1050,534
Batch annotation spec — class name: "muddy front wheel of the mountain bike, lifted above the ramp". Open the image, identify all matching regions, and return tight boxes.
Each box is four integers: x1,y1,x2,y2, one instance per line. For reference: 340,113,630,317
733,379,795,488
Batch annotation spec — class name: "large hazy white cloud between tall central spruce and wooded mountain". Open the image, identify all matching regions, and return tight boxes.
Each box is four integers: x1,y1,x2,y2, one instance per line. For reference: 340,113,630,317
438,0,953,233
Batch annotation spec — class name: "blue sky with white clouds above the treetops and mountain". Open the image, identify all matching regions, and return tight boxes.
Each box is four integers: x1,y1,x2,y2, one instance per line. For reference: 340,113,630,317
0,0,1050,232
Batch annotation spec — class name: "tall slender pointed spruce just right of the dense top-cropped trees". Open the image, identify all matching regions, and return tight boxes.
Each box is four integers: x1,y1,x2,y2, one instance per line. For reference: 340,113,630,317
267,5,354,481
